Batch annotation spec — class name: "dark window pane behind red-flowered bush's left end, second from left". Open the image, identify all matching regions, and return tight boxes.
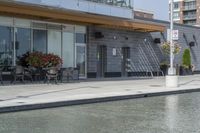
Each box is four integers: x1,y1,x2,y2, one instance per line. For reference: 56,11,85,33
15,28,31,61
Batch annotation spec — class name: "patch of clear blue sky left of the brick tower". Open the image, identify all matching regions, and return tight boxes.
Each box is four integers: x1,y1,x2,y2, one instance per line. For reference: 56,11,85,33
134,0,169,20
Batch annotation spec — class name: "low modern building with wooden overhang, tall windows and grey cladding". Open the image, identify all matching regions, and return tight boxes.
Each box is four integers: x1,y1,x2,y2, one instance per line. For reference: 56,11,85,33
0,0,200,78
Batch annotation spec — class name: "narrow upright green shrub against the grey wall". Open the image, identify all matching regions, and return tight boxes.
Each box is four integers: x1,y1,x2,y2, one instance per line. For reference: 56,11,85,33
182,49,191,69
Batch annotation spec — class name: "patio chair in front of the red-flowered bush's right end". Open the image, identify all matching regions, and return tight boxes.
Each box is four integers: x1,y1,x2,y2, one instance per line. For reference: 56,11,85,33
46,67,58,83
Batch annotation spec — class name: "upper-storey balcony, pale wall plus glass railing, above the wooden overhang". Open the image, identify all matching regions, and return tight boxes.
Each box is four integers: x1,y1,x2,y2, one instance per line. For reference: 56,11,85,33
12,0,133,19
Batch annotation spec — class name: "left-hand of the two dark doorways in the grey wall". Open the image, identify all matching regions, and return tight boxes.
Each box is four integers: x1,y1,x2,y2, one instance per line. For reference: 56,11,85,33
97,45,107,77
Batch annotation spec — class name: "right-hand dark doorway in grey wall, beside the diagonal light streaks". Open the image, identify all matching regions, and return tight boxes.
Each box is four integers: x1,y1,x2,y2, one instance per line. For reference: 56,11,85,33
122,47,131,77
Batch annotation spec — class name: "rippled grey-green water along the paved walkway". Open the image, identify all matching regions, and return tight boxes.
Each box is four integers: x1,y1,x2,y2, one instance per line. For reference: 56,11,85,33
0,93,200,133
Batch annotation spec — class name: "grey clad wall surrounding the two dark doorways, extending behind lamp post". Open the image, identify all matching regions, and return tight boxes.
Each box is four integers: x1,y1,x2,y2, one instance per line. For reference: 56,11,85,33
87,21,200,76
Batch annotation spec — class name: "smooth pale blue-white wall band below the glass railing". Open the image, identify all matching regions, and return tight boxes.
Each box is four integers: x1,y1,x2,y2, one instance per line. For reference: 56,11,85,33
15,0,133,18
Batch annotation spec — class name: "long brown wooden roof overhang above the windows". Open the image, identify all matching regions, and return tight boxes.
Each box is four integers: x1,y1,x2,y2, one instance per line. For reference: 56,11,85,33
0,1,166,32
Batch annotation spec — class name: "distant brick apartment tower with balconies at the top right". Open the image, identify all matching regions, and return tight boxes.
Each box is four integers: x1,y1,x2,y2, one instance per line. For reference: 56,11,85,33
170,0,200,26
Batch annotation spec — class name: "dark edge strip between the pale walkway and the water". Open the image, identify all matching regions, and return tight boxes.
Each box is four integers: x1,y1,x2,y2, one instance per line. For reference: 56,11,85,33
0,88,200,114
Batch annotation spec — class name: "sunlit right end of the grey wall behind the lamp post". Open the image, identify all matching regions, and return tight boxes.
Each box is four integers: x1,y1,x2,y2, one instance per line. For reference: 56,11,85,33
151,22,200,71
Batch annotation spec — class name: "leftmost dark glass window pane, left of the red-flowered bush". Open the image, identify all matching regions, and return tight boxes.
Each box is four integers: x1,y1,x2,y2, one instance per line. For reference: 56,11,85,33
0,26,13,66
